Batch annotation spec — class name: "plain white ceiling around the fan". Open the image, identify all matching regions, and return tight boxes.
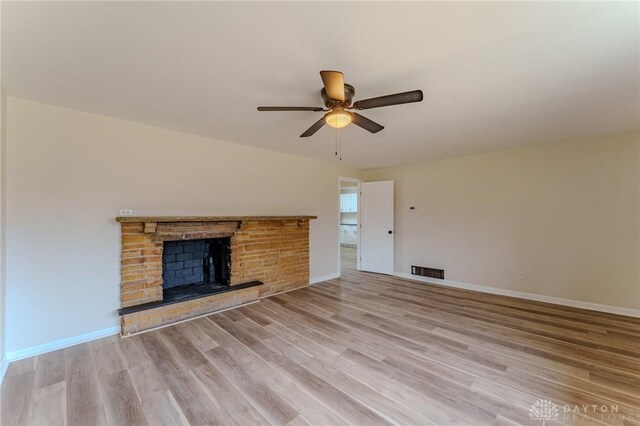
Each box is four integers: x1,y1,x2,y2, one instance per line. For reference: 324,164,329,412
2,1,640,168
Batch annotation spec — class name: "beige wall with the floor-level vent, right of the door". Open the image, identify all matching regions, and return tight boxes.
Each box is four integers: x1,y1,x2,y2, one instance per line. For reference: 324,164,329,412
365,134,640,309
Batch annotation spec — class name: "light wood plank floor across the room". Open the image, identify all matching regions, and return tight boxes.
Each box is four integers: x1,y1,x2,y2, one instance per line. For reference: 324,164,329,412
0,249,640,426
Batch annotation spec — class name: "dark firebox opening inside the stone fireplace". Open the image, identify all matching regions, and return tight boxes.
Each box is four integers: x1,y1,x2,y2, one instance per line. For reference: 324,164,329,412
162,238,231,302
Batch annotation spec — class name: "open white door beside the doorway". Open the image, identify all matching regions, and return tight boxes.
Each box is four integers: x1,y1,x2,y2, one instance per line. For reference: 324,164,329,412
359,180,394,274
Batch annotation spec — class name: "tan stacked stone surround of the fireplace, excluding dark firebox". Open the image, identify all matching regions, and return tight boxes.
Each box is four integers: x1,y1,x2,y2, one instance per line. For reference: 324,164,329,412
117,216,315,335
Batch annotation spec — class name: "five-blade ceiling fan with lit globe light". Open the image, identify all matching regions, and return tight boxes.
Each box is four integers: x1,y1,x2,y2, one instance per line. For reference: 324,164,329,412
258,71,422,138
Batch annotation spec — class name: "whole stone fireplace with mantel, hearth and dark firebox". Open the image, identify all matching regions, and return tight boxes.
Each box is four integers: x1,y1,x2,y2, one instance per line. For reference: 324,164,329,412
117,216,315,336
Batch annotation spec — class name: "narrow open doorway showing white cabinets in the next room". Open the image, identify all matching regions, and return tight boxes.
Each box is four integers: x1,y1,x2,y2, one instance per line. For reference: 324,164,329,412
338,177,360,273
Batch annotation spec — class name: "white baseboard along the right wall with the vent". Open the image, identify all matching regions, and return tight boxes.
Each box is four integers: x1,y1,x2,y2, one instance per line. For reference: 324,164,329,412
393,271,640,318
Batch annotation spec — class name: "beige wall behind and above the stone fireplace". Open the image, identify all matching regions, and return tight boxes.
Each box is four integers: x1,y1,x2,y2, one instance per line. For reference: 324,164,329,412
7,97,357,352
